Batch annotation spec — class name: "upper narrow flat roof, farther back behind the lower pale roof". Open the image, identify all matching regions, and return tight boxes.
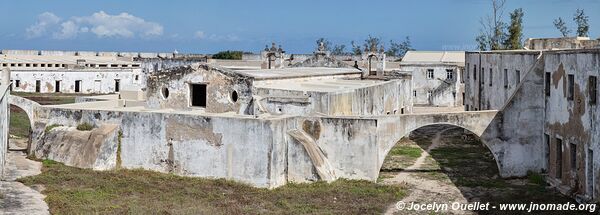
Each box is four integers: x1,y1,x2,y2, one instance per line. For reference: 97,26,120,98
235,67,361,79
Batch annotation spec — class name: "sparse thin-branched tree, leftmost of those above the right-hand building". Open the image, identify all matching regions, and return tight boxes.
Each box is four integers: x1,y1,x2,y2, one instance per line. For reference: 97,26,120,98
476,0,507,50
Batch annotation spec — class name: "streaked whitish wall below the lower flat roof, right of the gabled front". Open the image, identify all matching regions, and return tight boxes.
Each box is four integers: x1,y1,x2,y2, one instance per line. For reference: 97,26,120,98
254,79,412,116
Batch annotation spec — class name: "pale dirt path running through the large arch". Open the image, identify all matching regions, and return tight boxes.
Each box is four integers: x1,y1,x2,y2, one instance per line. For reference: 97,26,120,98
383,129,473,214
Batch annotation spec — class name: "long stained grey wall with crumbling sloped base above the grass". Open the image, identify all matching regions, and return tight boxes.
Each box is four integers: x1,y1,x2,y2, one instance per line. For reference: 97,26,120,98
32,108,291,187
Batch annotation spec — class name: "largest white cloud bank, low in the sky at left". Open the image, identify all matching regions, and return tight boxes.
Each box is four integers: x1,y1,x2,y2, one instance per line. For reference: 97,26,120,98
27,11,163,39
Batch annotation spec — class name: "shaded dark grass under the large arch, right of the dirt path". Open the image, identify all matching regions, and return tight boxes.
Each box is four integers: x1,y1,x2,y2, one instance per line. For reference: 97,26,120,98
382,127,574,214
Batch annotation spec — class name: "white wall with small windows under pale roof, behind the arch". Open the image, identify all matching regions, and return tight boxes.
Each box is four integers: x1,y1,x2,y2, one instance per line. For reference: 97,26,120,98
400,64,464,107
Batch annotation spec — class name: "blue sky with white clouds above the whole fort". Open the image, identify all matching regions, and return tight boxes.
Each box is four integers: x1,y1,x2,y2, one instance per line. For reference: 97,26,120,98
0,0,600,53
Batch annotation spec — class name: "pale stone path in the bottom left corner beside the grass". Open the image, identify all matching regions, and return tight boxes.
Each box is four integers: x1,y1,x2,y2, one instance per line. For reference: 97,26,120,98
0,151,50,214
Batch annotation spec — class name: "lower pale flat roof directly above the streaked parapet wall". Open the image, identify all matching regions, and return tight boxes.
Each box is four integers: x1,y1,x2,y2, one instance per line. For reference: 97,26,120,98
255,79,392,93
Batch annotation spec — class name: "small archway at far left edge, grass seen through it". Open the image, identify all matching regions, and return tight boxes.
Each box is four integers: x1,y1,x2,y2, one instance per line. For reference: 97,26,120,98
8,104,32,152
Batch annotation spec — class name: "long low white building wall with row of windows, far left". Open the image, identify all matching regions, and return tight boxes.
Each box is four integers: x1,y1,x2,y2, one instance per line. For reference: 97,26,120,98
5,69,146,94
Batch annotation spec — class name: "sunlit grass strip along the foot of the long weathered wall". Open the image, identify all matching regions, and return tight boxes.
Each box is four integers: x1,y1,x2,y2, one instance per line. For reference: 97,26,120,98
20,161,405,214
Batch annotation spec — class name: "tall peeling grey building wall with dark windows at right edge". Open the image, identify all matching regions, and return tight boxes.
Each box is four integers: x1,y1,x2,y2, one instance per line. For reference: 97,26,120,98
467,49,600,200
